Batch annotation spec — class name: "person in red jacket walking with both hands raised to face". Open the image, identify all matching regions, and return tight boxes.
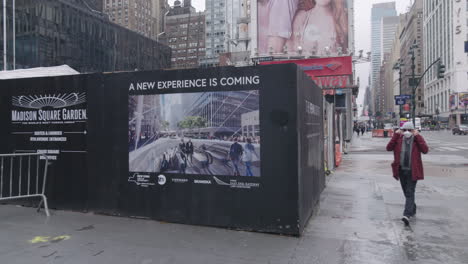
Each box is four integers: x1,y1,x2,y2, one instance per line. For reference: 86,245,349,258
387,122,429,226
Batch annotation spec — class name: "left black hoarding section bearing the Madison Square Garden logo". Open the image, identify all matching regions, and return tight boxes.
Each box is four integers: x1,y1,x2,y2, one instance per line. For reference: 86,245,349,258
0,75,96,210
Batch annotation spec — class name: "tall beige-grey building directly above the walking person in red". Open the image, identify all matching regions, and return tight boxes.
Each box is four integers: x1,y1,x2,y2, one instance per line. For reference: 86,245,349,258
400,0,424,115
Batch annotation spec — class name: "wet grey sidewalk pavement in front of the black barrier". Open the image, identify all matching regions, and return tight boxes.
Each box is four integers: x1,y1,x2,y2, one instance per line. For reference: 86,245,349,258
0,134,468,264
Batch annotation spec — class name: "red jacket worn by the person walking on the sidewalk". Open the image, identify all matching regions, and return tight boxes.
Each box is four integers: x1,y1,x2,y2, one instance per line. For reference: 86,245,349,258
387,133,429,181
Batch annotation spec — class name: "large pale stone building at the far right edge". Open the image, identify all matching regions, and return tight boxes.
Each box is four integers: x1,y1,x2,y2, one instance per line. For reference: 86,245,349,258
423,0,468,125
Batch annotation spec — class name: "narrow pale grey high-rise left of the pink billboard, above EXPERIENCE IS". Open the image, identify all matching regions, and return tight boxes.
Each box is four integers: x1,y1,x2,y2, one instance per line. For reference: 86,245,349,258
200,0,227,67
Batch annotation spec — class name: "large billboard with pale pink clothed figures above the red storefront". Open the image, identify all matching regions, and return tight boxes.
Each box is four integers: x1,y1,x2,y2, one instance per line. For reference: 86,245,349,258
258,0,349,55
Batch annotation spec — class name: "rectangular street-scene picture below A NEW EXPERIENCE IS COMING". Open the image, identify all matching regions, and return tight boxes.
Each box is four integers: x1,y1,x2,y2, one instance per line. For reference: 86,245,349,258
129,90,260,176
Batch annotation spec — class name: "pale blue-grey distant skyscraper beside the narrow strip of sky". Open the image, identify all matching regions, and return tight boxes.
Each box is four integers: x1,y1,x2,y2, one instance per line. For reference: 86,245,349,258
370,2,397,113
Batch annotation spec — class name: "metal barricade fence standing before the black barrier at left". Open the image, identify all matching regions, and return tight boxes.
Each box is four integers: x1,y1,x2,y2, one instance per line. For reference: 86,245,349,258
0,153,50,216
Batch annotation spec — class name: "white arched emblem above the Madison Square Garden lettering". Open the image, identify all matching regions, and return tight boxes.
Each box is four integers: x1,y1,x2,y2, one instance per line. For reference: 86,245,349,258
12,92,86,109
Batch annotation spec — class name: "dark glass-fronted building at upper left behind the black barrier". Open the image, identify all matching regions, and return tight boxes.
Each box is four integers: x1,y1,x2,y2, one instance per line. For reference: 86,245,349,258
0,0,171,73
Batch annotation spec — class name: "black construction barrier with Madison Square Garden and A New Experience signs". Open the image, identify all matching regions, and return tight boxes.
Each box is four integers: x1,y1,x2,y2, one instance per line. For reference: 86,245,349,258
0,64,325,235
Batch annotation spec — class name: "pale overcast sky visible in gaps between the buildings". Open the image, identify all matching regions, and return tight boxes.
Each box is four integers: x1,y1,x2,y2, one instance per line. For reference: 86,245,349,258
189,0,413,110
